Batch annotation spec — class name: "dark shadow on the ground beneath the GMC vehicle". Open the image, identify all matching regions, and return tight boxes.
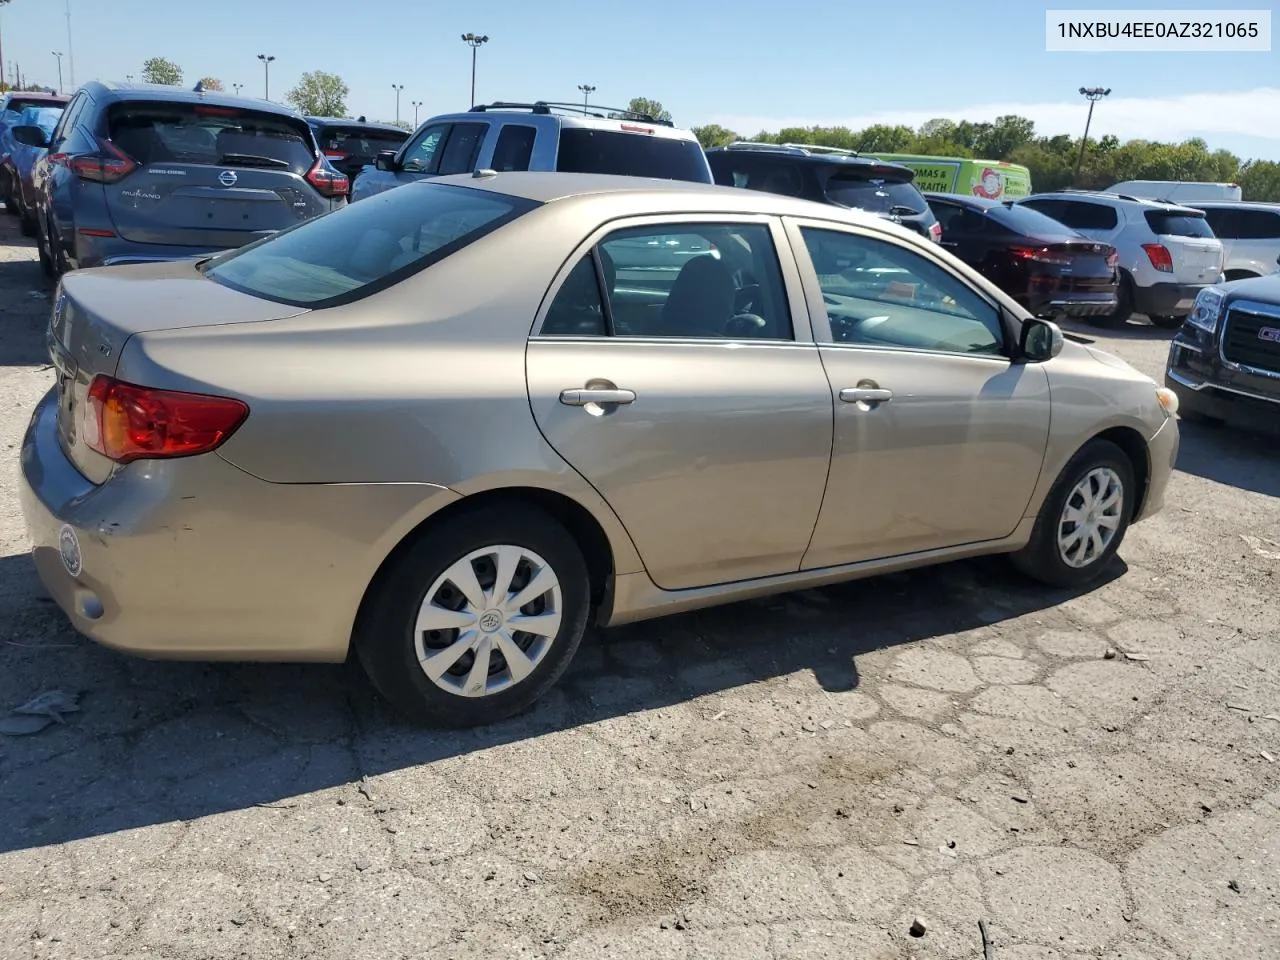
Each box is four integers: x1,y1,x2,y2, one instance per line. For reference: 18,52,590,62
1178,420,1280,497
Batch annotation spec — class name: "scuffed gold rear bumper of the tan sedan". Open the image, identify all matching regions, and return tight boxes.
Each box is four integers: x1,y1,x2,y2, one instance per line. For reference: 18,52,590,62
18,392,457,662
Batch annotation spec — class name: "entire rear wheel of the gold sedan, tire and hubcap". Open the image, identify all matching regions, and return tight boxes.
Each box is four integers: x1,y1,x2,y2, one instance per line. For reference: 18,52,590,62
355,506,590,727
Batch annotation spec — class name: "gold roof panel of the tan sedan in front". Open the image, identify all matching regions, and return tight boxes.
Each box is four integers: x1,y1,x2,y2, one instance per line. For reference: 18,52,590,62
422,172,911,228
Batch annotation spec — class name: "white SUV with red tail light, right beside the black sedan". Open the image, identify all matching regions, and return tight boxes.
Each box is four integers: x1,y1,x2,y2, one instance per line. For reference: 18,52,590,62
1015,191,1222,330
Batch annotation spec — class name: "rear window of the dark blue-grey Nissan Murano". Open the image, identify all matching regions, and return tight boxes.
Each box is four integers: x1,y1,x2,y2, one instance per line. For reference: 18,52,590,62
108,102,316,174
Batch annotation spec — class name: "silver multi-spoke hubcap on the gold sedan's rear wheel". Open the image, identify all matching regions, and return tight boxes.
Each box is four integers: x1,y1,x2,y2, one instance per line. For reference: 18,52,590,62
413,544,563,696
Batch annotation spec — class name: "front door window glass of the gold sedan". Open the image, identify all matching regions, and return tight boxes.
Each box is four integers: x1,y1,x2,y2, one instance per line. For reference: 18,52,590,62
801,227,1005,356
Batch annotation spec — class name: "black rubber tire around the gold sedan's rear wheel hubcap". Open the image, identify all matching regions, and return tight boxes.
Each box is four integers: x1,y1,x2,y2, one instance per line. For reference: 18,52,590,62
355,504,591,727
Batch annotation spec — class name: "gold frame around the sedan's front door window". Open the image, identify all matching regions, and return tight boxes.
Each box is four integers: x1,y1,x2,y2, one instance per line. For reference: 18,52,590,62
782,216,1025,365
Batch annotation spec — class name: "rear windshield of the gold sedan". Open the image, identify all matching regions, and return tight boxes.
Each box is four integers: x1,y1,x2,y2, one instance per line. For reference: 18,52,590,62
205,183,539,307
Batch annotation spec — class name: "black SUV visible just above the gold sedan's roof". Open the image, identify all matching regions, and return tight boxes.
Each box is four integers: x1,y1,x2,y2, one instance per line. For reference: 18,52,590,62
707,141,942,243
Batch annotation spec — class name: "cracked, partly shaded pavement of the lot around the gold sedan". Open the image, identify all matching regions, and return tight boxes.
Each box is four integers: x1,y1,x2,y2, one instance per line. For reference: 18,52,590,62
0,218,1280,960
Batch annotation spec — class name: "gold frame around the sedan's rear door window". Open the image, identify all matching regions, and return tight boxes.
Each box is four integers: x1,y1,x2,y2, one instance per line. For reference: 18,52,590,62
529,211,814,347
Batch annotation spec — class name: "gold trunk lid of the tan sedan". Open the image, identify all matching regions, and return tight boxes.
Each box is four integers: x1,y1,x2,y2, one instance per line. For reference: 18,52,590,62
46,261,307,484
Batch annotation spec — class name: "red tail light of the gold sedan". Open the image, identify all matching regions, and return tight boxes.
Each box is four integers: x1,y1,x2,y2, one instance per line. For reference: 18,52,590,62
81,376,248,463
